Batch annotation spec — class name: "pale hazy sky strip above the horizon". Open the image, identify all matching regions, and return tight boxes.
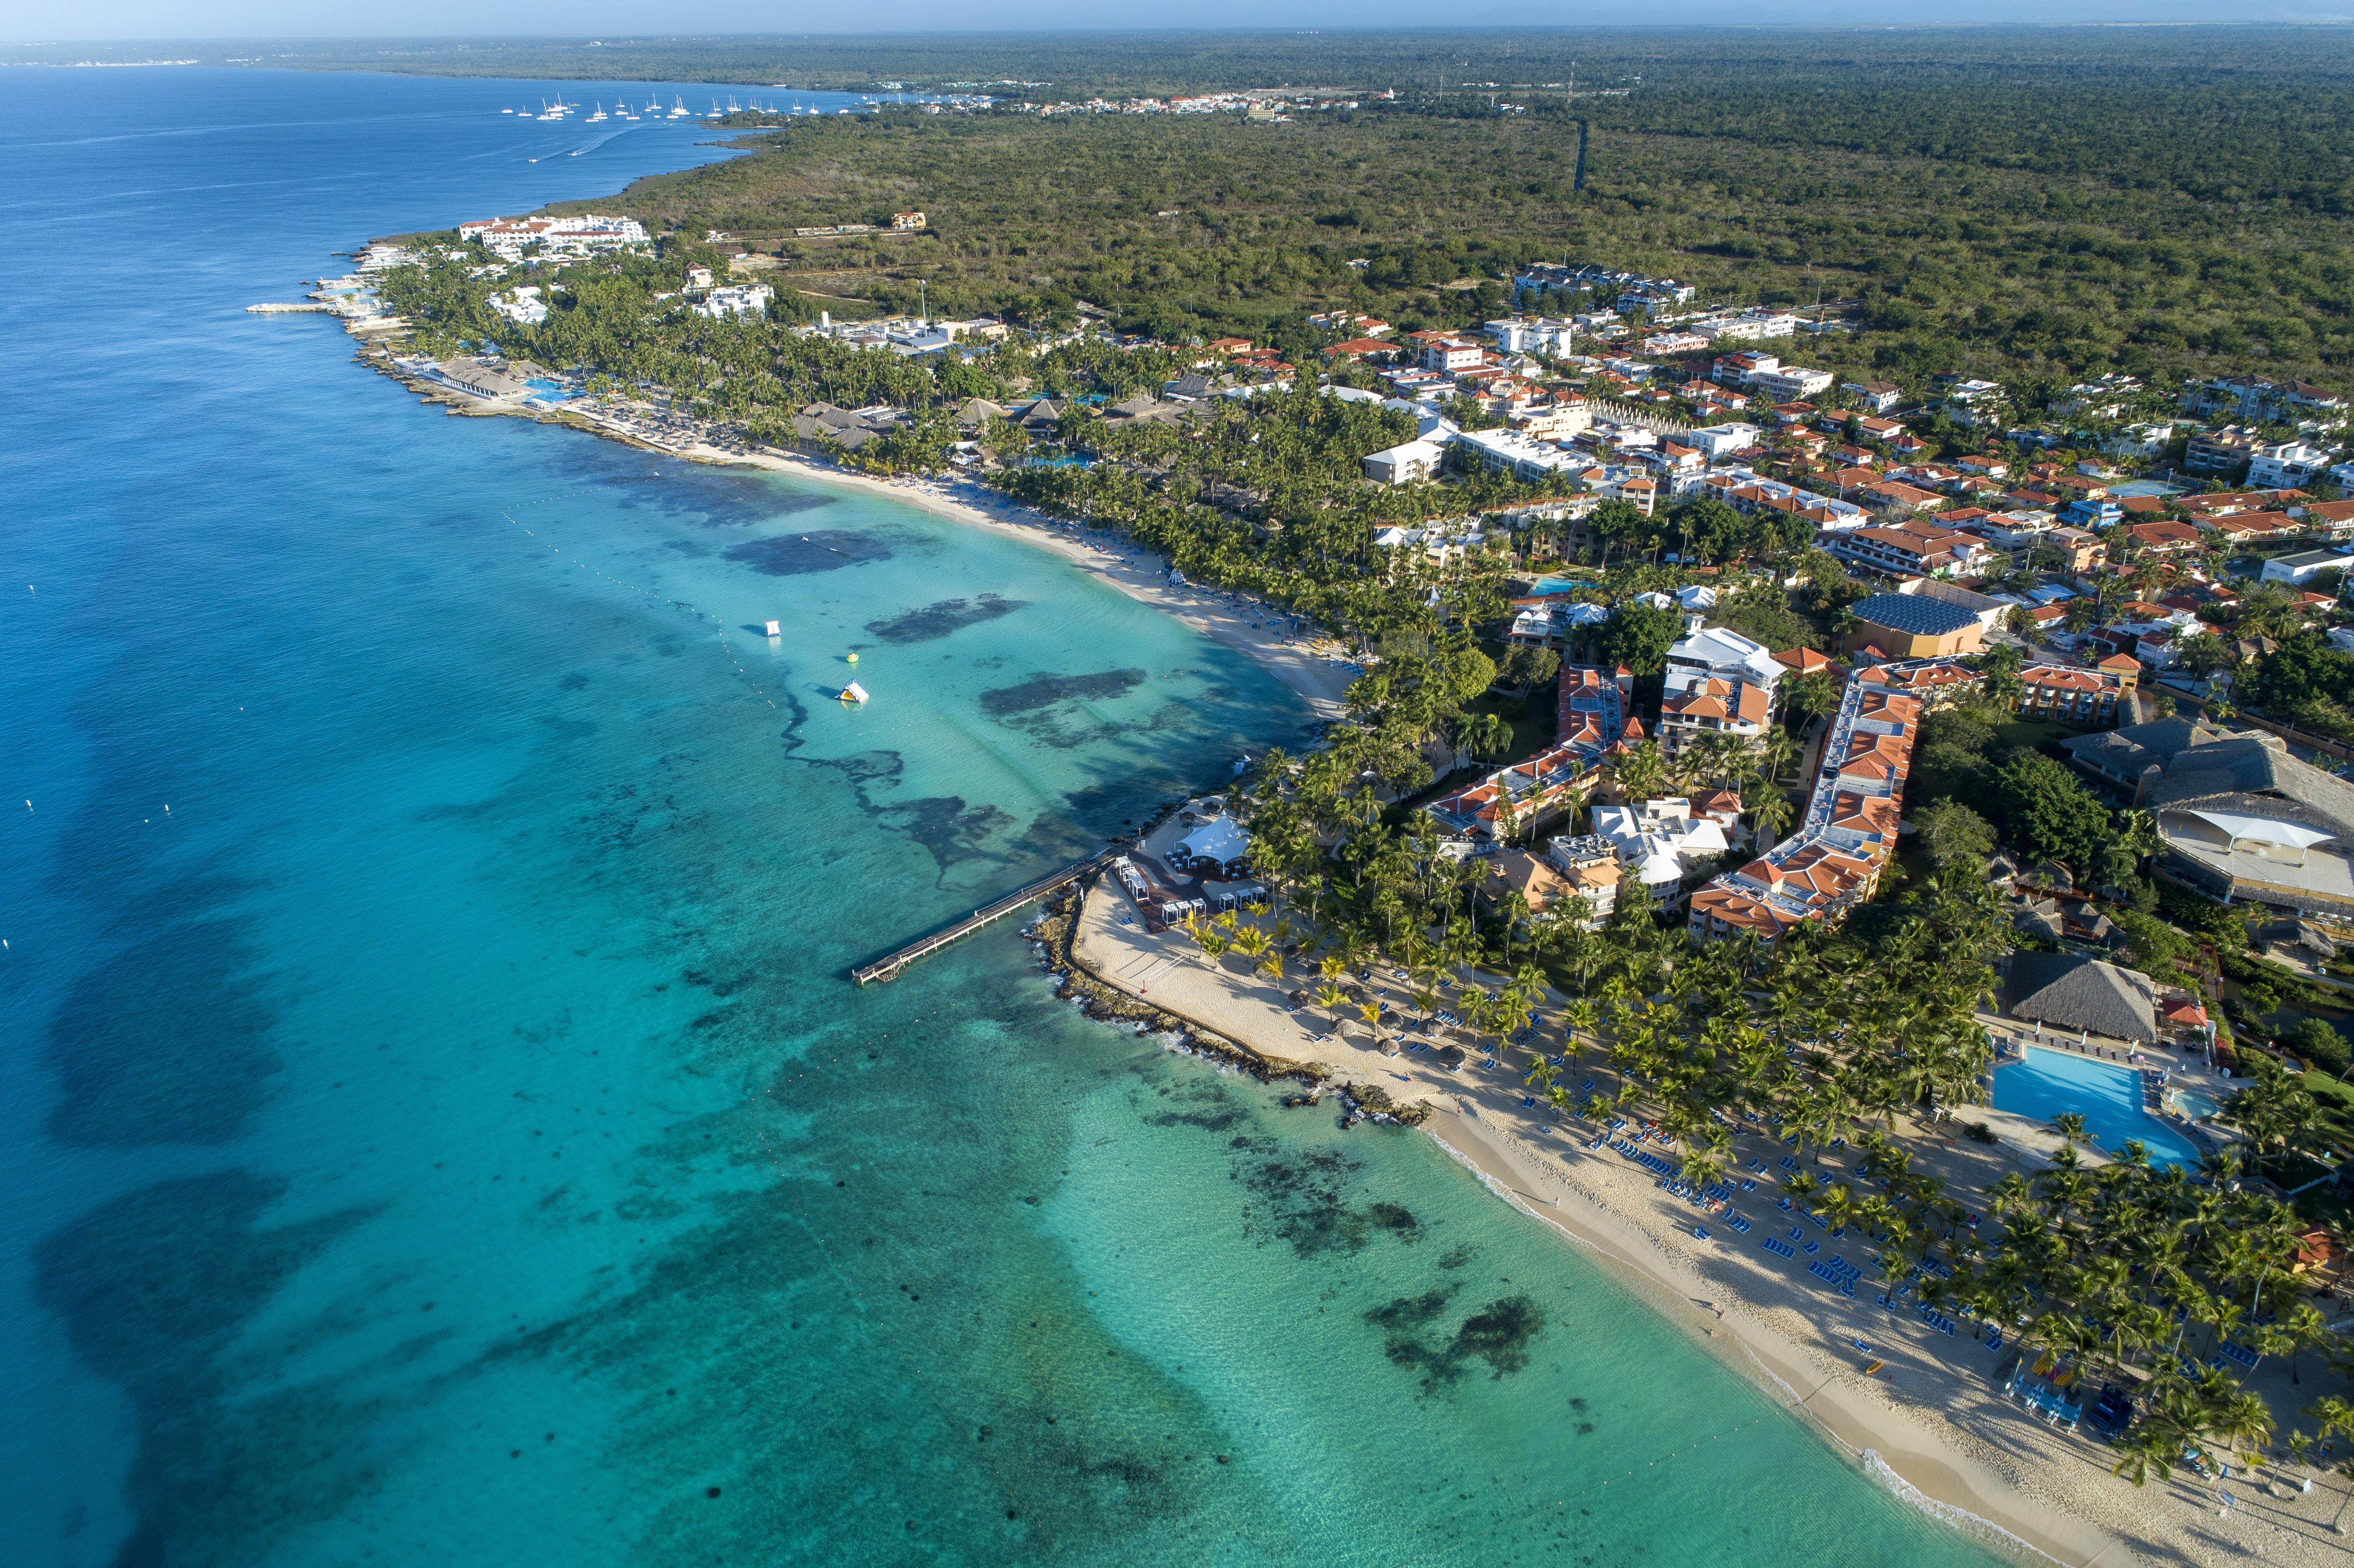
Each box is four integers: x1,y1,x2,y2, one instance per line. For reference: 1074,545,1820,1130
0,0,2354,42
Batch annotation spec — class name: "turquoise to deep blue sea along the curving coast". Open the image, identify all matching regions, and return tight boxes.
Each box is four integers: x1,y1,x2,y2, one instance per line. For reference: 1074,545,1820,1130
0,71,1987,1568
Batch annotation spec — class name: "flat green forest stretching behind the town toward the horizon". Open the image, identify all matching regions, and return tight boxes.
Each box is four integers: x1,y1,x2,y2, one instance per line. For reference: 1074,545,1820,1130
454,28,2354,389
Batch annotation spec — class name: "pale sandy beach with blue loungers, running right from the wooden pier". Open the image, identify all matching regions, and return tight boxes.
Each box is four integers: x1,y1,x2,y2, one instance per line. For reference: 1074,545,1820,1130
1074,878,2354,1568
